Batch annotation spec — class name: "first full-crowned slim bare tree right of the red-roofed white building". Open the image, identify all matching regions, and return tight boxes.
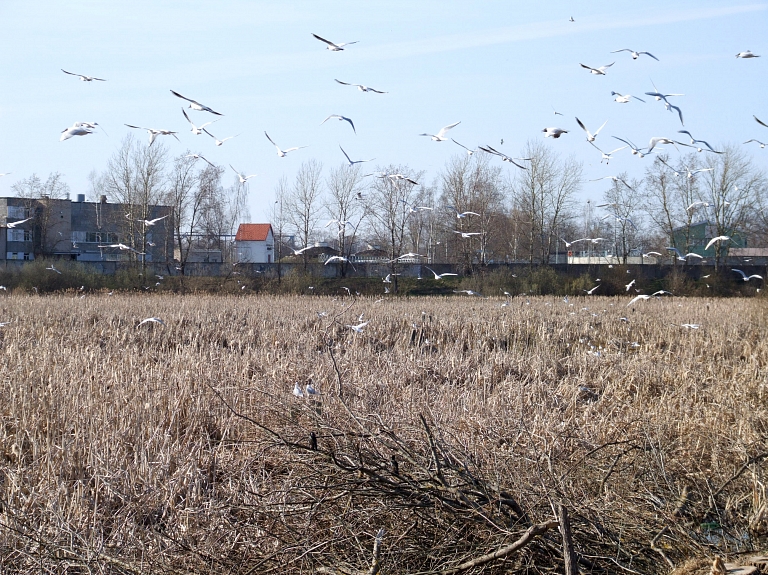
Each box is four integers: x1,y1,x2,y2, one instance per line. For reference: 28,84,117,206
285,160,323,269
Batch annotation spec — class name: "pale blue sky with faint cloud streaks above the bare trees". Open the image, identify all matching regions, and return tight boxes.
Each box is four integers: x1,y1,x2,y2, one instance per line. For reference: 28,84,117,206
0,0,768,221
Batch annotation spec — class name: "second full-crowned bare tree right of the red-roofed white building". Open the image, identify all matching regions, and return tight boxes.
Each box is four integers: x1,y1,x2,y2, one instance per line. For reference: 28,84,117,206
325,164,367,277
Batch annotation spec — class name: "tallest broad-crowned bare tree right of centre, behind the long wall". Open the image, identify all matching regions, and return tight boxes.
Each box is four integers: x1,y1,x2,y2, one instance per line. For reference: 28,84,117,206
513,141,582,264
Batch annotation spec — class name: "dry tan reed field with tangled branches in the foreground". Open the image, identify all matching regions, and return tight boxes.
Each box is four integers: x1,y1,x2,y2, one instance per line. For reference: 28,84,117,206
0,293,768,575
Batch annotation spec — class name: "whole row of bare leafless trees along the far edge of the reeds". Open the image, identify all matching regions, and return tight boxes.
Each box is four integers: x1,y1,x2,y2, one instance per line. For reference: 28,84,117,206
14,137,768,277
